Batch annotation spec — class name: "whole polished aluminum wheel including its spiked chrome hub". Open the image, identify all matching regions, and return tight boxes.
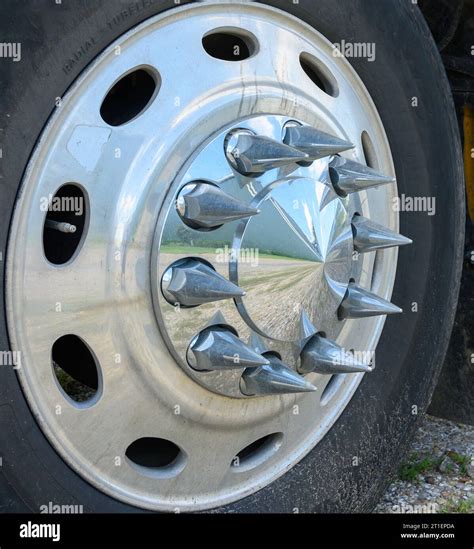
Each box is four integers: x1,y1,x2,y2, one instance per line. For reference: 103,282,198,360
7,2,410,510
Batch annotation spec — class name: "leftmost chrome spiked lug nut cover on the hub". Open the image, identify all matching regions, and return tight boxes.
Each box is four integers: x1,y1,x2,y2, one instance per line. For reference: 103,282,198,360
161,259,245,307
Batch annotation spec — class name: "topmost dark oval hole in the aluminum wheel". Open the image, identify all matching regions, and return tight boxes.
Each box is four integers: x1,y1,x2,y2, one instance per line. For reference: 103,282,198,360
202,28,258,61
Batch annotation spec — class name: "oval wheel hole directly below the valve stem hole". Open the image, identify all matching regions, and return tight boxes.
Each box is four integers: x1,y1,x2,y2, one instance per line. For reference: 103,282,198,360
51,334,102,407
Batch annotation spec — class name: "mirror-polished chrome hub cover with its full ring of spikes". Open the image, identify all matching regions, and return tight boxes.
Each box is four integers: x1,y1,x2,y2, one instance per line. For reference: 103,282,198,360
158,116,410,398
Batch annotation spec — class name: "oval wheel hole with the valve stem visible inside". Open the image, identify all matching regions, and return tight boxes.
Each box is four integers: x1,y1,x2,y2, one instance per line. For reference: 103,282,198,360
41,183,89,265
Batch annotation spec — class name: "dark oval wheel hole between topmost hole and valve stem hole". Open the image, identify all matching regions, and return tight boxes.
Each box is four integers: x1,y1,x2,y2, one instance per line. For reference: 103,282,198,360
100,68,161,126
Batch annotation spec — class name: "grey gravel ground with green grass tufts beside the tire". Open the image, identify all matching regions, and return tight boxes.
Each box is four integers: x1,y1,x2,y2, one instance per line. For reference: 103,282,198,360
375,416,474,513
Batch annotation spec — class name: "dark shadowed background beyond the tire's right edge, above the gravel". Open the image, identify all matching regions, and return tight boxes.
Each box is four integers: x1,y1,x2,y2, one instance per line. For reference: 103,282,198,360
419,0,474,425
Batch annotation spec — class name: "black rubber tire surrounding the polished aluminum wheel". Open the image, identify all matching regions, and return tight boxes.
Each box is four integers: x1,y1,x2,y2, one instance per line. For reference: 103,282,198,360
0,0,464,512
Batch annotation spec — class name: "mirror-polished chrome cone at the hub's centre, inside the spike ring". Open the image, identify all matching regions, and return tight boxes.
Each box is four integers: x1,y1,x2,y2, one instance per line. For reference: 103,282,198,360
231,177,353,341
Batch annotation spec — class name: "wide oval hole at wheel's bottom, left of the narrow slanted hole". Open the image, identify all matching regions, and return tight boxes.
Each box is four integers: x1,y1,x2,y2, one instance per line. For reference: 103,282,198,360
125,437,186,478
